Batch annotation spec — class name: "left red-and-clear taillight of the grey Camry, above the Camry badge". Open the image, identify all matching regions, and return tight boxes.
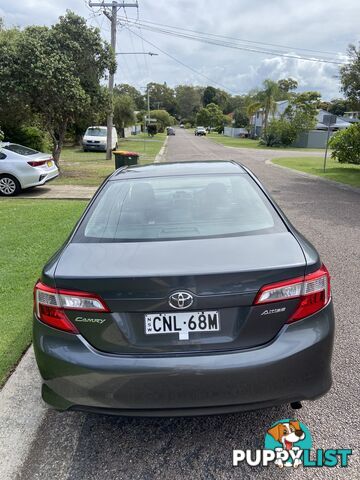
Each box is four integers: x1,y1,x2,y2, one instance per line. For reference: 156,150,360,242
34,282,110,333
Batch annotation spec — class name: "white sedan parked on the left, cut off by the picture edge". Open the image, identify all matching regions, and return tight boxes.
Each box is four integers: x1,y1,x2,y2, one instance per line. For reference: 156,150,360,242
0,142,59,196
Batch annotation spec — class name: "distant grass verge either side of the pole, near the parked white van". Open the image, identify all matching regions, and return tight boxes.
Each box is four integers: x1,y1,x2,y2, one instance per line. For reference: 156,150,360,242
53,133,166,186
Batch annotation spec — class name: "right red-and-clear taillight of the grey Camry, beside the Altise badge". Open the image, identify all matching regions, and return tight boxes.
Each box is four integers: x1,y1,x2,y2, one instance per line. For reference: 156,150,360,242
254,265,331,323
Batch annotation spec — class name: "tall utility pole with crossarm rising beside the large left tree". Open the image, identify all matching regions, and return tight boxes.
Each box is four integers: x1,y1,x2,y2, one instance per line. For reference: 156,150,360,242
89,0,138,160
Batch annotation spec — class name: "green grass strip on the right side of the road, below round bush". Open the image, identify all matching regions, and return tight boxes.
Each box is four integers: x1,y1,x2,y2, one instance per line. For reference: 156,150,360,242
271,157,360,187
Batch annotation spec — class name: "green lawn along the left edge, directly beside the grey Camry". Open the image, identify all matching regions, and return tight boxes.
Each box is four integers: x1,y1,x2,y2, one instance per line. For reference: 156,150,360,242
0,199,86,385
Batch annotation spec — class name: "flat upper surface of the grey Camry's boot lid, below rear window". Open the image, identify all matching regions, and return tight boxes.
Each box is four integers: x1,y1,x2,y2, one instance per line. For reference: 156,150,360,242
55,232,305,282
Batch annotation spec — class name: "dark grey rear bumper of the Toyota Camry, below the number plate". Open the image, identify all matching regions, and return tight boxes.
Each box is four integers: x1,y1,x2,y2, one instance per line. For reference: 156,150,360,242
34,303,334,416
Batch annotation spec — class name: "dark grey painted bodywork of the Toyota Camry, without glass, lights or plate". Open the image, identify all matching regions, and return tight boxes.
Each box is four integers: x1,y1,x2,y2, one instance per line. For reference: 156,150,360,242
34,158,333,415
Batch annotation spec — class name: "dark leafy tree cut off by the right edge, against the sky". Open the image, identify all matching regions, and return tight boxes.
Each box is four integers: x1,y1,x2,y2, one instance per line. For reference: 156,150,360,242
340,45,360,108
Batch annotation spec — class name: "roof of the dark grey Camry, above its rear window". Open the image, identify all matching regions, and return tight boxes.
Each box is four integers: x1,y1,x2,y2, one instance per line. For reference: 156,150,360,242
109,160,247,180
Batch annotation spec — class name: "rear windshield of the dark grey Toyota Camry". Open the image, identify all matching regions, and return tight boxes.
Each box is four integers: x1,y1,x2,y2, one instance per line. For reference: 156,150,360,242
73,174,286,242
